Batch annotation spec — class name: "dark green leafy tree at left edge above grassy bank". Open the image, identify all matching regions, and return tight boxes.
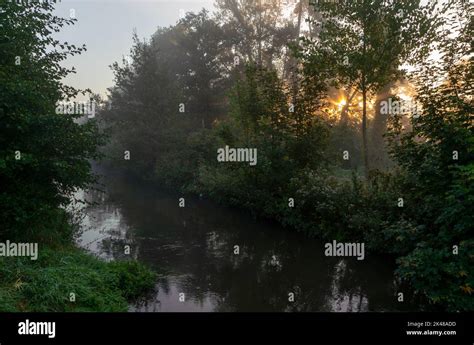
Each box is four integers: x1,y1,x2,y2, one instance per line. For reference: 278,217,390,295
0,1,103,239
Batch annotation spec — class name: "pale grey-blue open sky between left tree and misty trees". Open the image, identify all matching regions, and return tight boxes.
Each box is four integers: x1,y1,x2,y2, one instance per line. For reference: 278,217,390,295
54,0,214,96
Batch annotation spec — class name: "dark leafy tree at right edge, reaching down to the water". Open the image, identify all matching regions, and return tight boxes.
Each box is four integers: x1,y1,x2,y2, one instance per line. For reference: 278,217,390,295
390,1,474,311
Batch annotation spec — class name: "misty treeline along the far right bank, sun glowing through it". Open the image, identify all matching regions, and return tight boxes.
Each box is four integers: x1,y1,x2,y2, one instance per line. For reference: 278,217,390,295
100,0,474,310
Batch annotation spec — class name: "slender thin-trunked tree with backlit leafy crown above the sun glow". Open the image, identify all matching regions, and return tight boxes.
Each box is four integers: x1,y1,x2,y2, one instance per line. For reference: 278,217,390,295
302,0,449,176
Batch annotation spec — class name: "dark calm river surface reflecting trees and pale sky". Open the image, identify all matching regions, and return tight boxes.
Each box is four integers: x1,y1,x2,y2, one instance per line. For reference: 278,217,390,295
79,173,399,312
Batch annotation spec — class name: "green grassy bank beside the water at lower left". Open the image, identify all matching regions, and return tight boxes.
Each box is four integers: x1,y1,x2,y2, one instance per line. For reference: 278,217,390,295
0,246,156,312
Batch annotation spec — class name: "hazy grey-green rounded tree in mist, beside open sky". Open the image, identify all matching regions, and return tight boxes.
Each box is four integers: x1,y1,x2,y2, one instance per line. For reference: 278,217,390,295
102,10,233,184
